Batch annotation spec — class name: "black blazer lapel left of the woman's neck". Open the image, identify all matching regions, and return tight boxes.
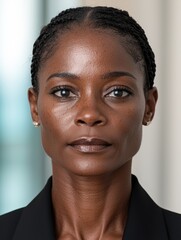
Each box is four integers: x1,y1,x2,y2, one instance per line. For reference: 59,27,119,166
13,179,56,240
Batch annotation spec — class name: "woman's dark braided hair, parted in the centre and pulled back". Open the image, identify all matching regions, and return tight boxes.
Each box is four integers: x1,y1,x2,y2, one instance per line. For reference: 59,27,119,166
31,7,156,92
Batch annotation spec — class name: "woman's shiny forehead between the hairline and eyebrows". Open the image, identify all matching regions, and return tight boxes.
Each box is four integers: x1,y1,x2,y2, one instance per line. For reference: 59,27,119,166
38,26,143,81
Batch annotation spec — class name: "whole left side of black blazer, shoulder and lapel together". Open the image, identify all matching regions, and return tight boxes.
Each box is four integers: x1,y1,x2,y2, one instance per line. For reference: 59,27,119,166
0,178,55,240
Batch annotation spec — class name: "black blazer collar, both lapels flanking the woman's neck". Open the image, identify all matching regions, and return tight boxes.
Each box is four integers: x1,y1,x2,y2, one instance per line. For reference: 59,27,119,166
13,176,168,240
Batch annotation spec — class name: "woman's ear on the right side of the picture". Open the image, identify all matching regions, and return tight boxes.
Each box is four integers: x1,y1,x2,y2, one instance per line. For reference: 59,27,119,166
143,87,158,126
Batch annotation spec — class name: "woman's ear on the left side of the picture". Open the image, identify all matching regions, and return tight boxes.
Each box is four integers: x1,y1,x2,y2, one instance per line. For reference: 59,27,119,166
28,88,39,124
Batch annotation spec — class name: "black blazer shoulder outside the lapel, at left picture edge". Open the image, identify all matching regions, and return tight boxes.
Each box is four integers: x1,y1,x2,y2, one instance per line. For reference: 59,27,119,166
0,208,23,240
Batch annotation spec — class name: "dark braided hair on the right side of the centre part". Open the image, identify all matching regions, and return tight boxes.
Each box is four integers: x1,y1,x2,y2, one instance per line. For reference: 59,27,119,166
90,7,156,89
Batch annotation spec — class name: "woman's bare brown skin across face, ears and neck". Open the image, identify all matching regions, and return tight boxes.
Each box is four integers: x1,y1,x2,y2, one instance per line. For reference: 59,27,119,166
28,27,157,240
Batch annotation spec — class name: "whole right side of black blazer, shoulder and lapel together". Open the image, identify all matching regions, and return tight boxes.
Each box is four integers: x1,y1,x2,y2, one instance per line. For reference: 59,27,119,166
126,176,181,240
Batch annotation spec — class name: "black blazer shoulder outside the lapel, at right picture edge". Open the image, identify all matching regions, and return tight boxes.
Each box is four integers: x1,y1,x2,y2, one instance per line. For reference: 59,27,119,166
162,209,181,240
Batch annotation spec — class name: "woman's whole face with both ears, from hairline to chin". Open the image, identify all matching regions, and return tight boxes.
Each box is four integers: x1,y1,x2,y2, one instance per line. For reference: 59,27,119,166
29,27,157,175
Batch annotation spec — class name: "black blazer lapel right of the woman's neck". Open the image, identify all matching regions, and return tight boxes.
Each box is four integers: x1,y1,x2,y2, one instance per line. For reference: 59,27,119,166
123,176,168,240
